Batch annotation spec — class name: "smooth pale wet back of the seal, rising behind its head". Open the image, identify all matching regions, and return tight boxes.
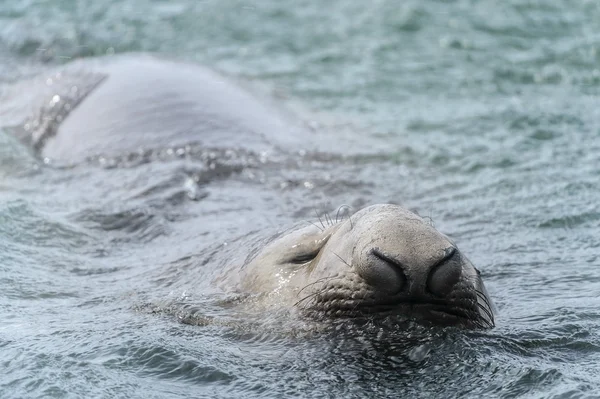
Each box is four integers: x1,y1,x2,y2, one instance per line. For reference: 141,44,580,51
0,54,314,163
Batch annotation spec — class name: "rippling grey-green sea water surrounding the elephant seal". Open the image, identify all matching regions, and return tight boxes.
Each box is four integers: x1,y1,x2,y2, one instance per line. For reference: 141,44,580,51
0,0,600,398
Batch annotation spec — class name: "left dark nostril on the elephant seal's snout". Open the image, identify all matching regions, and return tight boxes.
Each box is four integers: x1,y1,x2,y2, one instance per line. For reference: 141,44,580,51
358,248,406,295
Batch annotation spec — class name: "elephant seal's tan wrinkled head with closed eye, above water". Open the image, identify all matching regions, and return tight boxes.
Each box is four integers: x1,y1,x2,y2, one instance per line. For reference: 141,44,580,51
242,204,494,328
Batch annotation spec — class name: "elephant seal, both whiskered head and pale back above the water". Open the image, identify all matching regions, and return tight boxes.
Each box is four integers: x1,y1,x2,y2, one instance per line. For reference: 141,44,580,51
0,56,494,328
